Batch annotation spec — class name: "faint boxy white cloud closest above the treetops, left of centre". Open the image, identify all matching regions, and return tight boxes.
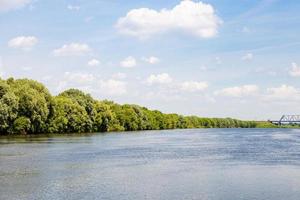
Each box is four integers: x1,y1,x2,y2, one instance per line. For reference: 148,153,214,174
99,79,127,96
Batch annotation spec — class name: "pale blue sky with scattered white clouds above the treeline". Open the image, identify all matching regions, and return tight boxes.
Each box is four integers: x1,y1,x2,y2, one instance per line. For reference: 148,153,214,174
0,0,300,120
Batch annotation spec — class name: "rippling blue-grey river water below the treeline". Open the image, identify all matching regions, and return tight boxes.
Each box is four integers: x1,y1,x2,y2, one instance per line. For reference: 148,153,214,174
0,129,300,200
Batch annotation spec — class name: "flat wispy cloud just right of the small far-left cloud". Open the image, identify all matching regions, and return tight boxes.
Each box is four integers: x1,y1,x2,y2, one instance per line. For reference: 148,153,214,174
53,43,91,56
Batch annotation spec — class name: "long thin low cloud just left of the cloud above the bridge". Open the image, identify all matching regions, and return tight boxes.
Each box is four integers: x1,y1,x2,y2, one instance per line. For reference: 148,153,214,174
215,85,259,97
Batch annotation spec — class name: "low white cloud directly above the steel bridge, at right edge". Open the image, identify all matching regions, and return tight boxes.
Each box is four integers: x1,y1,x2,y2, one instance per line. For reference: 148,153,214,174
265,84,300,100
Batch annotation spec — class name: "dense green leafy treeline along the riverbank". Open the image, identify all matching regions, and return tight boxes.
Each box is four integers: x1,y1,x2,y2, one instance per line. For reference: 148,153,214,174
0,78,272,135
